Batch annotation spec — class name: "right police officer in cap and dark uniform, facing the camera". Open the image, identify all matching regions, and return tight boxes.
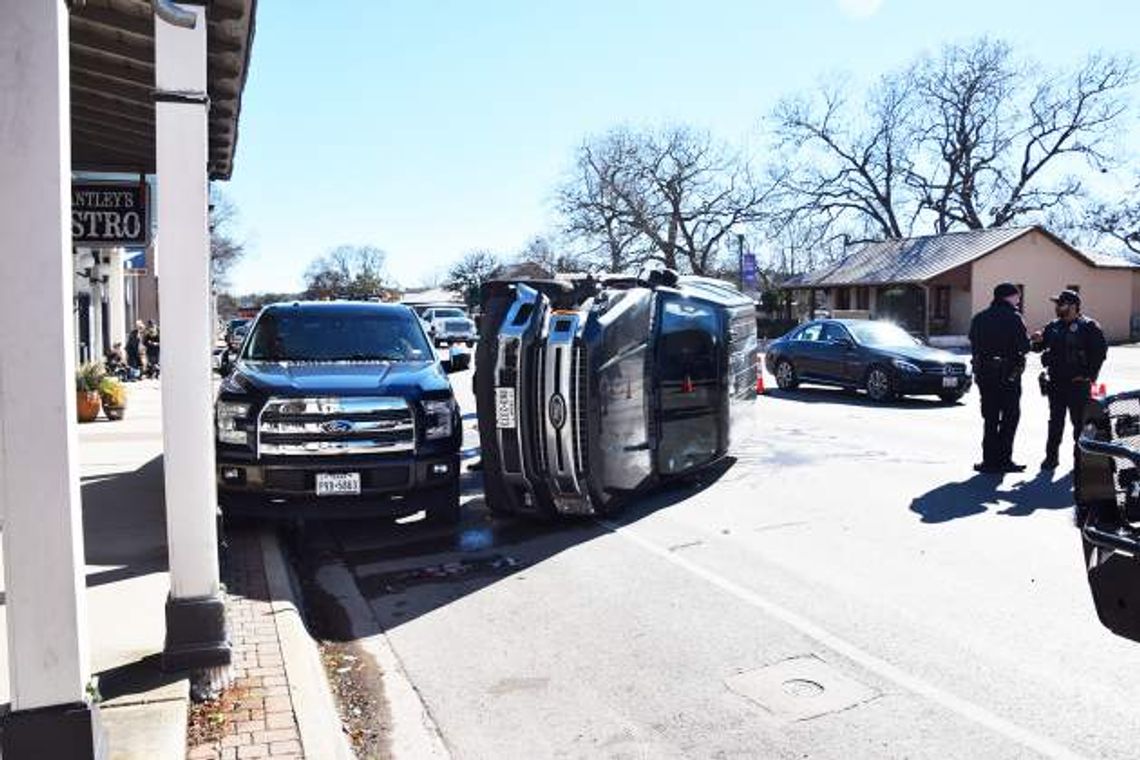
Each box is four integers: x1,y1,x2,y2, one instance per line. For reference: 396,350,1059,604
1033,291,1108,469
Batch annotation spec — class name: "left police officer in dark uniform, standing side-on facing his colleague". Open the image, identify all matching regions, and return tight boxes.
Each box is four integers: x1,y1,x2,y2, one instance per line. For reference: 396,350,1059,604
970,283,1029,473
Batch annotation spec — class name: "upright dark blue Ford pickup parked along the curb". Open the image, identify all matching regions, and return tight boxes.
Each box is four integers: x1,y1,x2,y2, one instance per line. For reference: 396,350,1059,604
214,302,463,522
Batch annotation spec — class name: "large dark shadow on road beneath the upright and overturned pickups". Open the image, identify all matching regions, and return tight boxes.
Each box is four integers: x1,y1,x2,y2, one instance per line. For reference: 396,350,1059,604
287,458,735,641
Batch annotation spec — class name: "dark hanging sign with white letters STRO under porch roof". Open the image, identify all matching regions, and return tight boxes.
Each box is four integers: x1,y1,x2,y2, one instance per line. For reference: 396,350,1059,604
72,185,150,246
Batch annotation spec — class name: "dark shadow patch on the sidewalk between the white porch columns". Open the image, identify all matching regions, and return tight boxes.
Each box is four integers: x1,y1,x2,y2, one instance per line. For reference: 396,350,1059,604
81,456,168,586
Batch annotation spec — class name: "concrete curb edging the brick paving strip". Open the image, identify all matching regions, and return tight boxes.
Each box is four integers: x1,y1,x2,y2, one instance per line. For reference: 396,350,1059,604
260,530,355,760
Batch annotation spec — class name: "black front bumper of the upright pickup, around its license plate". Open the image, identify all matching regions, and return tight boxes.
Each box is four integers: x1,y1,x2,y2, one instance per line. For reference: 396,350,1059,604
217,451,459,518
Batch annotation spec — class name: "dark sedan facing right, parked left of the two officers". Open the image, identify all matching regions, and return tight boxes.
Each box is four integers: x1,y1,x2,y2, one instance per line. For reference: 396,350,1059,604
764,319,974,403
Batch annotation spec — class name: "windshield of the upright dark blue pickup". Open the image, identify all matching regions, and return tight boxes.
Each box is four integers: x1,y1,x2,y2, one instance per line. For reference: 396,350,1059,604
245,311,434,361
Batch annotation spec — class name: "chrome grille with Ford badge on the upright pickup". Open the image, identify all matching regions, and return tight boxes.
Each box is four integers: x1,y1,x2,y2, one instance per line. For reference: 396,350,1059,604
258,397,416,457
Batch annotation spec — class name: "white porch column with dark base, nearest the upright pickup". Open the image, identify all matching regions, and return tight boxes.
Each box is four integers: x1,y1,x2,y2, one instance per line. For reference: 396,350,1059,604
154,3,230,672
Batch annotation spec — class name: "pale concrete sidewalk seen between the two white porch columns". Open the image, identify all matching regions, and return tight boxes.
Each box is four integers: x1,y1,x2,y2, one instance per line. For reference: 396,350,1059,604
0,381,189,760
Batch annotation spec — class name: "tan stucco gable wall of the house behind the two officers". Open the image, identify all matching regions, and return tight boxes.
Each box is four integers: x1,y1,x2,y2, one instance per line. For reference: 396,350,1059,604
970,230,1140,341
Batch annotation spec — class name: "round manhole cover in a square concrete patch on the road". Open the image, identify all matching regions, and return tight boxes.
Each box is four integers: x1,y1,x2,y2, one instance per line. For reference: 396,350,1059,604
725,655,878,721
